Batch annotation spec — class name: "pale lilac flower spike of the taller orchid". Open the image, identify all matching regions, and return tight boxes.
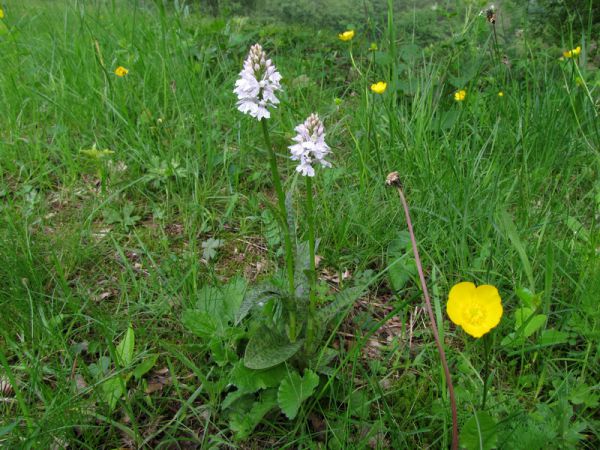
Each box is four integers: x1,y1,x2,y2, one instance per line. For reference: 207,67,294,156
233,44,281,120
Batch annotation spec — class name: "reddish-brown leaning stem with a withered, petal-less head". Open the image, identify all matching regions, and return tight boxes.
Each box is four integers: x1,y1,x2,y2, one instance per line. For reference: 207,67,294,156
386,172,458,450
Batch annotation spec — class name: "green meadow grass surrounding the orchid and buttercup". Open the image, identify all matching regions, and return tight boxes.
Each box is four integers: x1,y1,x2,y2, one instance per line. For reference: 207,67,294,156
0,0,600,449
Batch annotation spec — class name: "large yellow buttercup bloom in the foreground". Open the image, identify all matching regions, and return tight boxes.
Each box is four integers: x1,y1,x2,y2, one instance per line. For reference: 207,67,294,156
446,281,503,338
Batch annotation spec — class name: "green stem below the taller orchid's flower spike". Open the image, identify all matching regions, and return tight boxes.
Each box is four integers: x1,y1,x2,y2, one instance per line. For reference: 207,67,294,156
260,119,296,341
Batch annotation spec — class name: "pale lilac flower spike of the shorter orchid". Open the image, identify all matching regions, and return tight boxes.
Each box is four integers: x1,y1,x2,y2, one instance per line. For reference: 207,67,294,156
289,114,331,177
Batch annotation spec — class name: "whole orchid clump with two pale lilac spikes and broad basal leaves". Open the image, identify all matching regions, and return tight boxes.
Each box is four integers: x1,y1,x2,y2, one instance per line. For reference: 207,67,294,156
183,44,369,438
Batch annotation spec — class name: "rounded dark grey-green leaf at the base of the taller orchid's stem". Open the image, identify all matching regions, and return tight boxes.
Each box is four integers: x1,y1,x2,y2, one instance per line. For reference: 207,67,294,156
244,325,304,369
